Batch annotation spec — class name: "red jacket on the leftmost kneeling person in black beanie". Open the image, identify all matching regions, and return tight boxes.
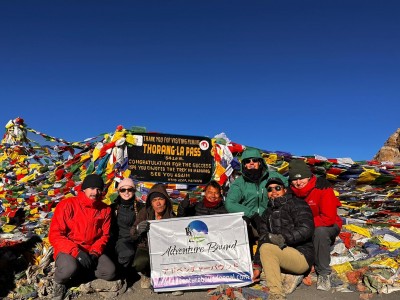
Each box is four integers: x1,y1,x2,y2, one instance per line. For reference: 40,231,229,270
49,192,111,259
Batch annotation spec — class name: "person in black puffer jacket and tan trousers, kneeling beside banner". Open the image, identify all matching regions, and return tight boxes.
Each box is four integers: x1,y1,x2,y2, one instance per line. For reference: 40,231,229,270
253,178,314,300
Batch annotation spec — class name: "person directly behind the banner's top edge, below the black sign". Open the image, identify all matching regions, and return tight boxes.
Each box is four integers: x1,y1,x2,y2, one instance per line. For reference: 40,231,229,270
177,180,228,217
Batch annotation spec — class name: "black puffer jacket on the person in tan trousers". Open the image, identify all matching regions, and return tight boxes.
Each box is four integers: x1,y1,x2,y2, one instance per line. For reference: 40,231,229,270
254,194,314,267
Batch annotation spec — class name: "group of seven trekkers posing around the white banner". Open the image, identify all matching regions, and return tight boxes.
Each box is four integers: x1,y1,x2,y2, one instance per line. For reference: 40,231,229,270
49,148,342,300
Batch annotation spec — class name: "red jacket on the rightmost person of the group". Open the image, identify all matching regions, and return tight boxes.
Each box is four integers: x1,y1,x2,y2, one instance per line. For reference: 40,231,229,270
290,176,342,228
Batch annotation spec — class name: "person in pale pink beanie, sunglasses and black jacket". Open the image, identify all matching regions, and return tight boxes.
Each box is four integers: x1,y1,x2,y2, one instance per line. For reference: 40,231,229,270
109,178,144,275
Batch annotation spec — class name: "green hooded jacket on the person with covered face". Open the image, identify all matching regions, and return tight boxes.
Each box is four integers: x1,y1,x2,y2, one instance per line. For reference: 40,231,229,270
225,148,287,218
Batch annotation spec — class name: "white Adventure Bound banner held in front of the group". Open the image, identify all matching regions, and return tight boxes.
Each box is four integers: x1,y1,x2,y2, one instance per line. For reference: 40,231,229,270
149,213,253,292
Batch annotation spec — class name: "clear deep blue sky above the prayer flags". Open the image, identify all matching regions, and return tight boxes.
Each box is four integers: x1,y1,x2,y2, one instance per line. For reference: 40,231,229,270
0,0,400,160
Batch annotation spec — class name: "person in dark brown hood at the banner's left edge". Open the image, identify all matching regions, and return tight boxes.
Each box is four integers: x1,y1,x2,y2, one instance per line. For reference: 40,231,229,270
130,183,175,289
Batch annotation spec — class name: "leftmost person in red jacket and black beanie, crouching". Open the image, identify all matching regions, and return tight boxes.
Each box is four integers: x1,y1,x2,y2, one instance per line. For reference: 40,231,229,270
49,174,115,299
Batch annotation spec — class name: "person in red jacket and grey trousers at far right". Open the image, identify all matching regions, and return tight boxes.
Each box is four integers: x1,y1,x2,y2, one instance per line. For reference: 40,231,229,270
289,159,342,291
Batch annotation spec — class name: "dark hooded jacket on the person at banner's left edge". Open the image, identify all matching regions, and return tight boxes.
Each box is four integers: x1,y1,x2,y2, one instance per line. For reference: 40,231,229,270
131,183,175,248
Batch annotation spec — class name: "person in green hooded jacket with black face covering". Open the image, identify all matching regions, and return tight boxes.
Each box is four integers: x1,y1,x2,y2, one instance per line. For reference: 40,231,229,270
225,148,287,255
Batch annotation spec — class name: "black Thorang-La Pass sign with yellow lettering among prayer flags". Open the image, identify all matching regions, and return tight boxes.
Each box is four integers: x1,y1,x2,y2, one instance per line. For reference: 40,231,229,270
128,133,213,184
